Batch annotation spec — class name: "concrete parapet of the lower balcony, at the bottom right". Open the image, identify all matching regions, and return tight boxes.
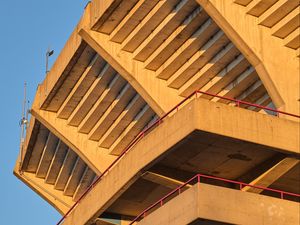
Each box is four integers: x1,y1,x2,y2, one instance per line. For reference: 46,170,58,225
138,183,300,225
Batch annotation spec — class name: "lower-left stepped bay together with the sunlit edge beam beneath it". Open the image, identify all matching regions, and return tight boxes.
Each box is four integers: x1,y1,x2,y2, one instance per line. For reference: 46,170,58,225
15,118,99,212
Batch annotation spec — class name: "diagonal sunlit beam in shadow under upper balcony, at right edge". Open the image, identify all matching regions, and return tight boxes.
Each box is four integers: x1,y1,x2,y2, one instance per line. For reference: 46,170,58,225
242,158,300,193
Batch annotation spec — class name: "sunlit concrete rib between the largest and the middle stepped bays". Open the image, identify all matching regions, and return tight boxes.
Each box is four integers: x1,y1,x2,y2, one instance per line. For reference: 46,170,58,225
79,29,182,116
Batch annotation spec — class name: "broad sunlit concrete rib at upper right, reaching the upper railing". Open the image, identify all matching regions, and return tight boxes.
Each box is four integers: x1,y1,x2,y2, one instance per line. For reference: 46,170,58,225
197,0,300,116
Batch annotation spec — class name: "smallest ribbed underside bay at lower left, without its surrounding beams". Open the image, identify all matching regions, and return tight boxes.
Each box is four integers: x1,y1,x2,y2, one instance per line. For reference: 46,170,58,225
22,122,97,201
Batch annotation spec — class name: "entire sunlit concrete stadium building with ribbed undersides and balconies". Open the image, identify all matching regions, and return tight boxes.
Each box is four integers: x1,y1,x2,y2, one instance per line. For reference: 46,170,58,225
14,0,300,225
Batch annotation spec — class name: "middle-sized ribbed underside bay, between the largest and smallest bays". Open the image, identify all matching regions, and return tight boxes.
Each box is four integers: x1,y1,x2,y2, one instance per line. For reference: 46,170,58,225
41,46,157,155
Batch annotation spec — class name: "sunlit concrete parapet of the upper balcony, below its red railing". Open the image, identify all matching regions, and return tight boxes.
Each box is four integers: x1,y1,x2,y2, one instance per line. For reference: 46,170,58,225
64,99,299,225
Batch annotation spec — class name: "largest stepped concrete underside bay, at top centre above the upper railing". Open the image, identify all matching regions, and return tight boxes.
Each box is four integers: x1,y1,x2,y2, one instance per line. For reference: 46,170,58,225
93,0,271,110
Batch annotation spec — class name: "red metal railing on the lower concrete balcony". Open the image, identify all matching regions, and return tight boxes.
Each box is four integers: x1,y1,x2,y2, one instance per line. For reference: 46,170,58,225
129,174,300,225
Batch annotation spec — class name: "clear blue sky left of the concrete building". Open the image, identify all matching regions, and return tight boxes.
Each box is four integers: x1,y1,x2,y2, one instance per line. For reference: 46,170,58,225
0,0,88,225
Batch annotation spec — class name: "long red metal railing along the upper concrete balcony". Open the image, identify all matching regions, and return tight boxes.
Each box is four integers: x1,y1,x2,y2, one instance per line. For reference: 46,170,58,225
57,91,300,225
